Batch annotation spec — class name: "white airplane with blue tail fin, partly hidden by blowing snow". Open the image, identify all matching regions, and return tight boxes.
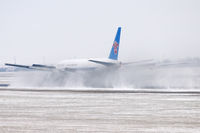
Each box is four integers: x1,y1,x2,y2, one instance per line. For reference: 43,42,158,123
5,27,152,72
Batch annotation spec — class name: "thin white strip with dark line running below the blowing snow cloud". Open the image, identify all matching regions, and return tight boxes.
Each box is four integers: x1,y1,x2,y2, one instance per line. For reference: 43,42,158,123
0,87,200,94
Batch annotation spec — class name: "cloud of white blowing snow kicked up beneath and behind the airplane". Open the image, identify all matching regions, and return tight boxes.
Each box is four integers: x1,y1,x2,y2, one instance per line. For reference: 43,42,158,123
11,59,200,89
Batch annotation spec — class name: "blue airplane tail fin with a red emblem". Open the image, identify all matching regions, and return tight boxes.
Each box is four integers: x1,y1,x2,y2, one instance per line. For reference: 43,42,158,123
109,27,121,60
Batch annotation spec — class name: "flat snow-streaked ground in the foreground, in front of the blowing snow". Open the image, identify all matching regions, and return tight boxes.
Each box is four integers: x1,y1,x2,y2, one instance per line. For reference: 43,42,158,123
0,88,200,133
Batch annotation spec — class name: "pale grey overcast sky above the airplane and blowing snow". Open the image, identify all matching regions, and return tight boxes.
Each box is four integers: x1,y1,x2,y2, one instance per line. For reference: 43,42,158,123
0,0,200,64
